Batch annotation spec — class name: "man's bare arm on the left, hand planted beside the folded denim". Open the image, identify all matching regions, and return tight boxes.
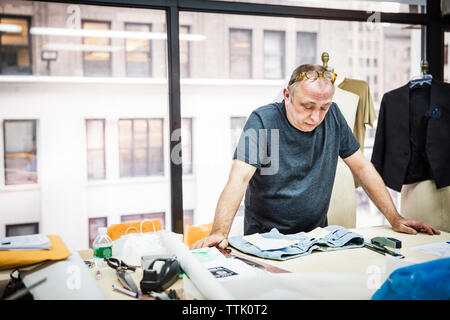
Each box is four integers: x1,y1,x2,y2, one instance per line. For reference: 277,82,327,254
191,159,256,249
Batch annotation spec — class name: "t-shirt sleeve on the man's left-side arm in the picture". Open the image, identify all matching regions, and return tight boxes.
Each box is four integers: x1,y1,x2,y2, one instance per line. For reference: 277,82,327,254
233,112,264,168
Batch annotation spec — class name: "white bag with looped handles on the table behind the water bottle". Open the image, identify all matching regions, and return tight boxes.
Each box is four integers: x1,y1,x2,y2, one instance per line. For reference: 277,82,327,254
112,220,165,257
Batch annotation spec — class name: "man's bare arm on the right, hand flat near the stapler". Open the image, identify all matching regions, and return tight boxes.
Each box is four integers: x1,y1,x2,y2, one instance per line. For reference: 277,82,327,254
344,150,440,234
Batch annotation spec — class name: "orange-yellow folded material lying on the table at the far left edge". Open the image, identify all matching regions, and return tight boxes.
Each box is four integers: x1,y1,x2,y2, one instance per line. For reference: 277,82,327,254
0,235,70,270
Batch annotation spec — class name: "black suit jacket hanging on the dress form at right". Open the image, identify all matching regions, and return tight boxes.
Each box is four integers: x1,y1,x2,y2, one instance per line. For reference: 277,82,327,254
371,79,450,192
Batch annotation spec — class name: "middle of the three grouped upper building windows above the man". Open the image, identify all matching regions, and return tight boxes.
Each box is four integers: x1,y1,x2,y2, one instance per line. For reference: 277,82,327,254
264,30,285,79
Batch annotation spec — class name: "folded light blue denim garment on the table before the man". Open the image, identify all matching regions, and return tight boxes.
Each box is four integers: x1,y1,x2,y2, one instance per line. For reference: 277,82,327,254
228,226,364,260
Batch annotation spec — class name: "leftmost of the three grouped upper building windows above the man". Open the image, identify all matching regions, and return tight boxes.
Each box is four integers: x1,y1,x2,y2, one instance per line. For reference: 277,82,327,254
230,29,253,79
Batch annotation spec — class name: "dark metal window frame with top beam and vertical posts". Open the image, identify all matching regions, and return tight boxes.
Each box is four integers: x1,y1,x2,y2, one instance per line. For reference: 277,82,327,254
28,0,450,233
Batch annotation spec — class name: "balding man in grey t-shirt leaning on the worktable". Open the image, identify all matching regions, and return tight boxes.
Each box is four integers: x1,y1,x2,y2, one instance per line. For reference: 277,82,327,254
191,65,440,249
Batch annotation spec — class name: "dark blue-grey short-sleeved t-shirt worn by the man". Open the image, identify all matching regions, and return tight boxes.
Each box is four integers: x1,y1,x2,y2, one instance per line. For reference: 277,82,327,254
233,101,359,235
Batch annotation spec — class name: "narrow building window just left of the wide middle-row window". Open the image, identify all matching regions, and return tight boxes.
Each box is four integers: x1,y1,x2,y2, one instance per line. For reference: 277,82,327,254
86,119,106,180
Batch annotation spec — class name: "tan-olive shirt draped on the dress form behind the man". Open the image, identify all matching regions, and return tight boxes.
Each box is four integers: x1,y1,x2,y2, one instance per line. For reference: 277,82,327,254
338,78,377,188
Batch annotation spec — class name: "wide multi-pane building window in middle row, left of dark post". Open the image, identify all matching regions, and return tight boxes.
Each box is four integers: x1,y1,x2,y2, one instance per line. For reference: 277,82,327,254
119,119,164,177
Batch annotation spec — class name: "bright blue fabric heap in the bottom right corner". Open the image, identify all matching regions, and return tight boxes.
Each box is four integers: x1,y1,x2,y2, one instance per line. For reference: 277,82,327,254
372,258,450,300
